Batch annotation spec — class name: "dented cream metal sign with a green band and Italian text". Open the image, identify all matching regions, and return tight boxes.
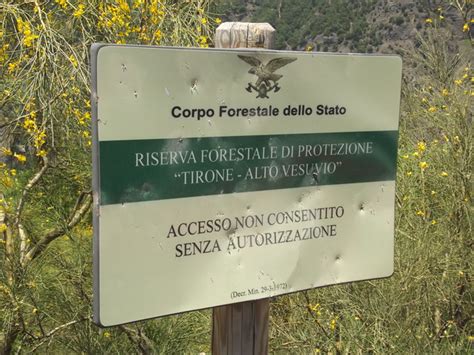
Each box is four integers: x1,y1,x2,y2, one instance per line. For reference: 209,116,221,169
92,45,401,326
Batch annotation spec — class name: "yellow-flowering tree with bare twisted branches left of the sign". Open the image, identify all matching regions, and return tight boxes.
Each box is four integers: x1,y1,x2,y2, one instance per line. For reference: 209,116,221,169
0,0,216,353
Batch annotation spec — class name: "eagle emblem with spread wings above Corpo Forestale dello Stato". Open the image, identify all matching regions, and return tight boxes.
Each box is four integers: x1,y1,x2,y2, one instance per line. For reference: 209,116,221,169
238,55,297,99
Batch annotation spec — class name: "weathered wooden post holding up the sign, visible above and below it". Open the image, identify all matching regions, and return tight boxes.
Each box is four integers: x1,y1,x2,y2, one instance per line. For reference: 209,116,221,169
212,22,275,355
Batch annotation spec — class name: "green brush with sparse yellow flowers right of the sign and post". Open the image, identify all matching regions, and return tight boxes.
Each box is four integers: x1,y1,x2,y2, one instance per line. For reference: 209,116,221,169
271,27,474,354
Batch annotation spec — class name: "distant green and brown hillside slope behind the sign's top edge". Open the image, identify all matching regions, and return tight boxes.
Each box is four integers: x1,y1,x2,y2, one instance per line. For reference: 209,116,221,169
216,0,472,53
